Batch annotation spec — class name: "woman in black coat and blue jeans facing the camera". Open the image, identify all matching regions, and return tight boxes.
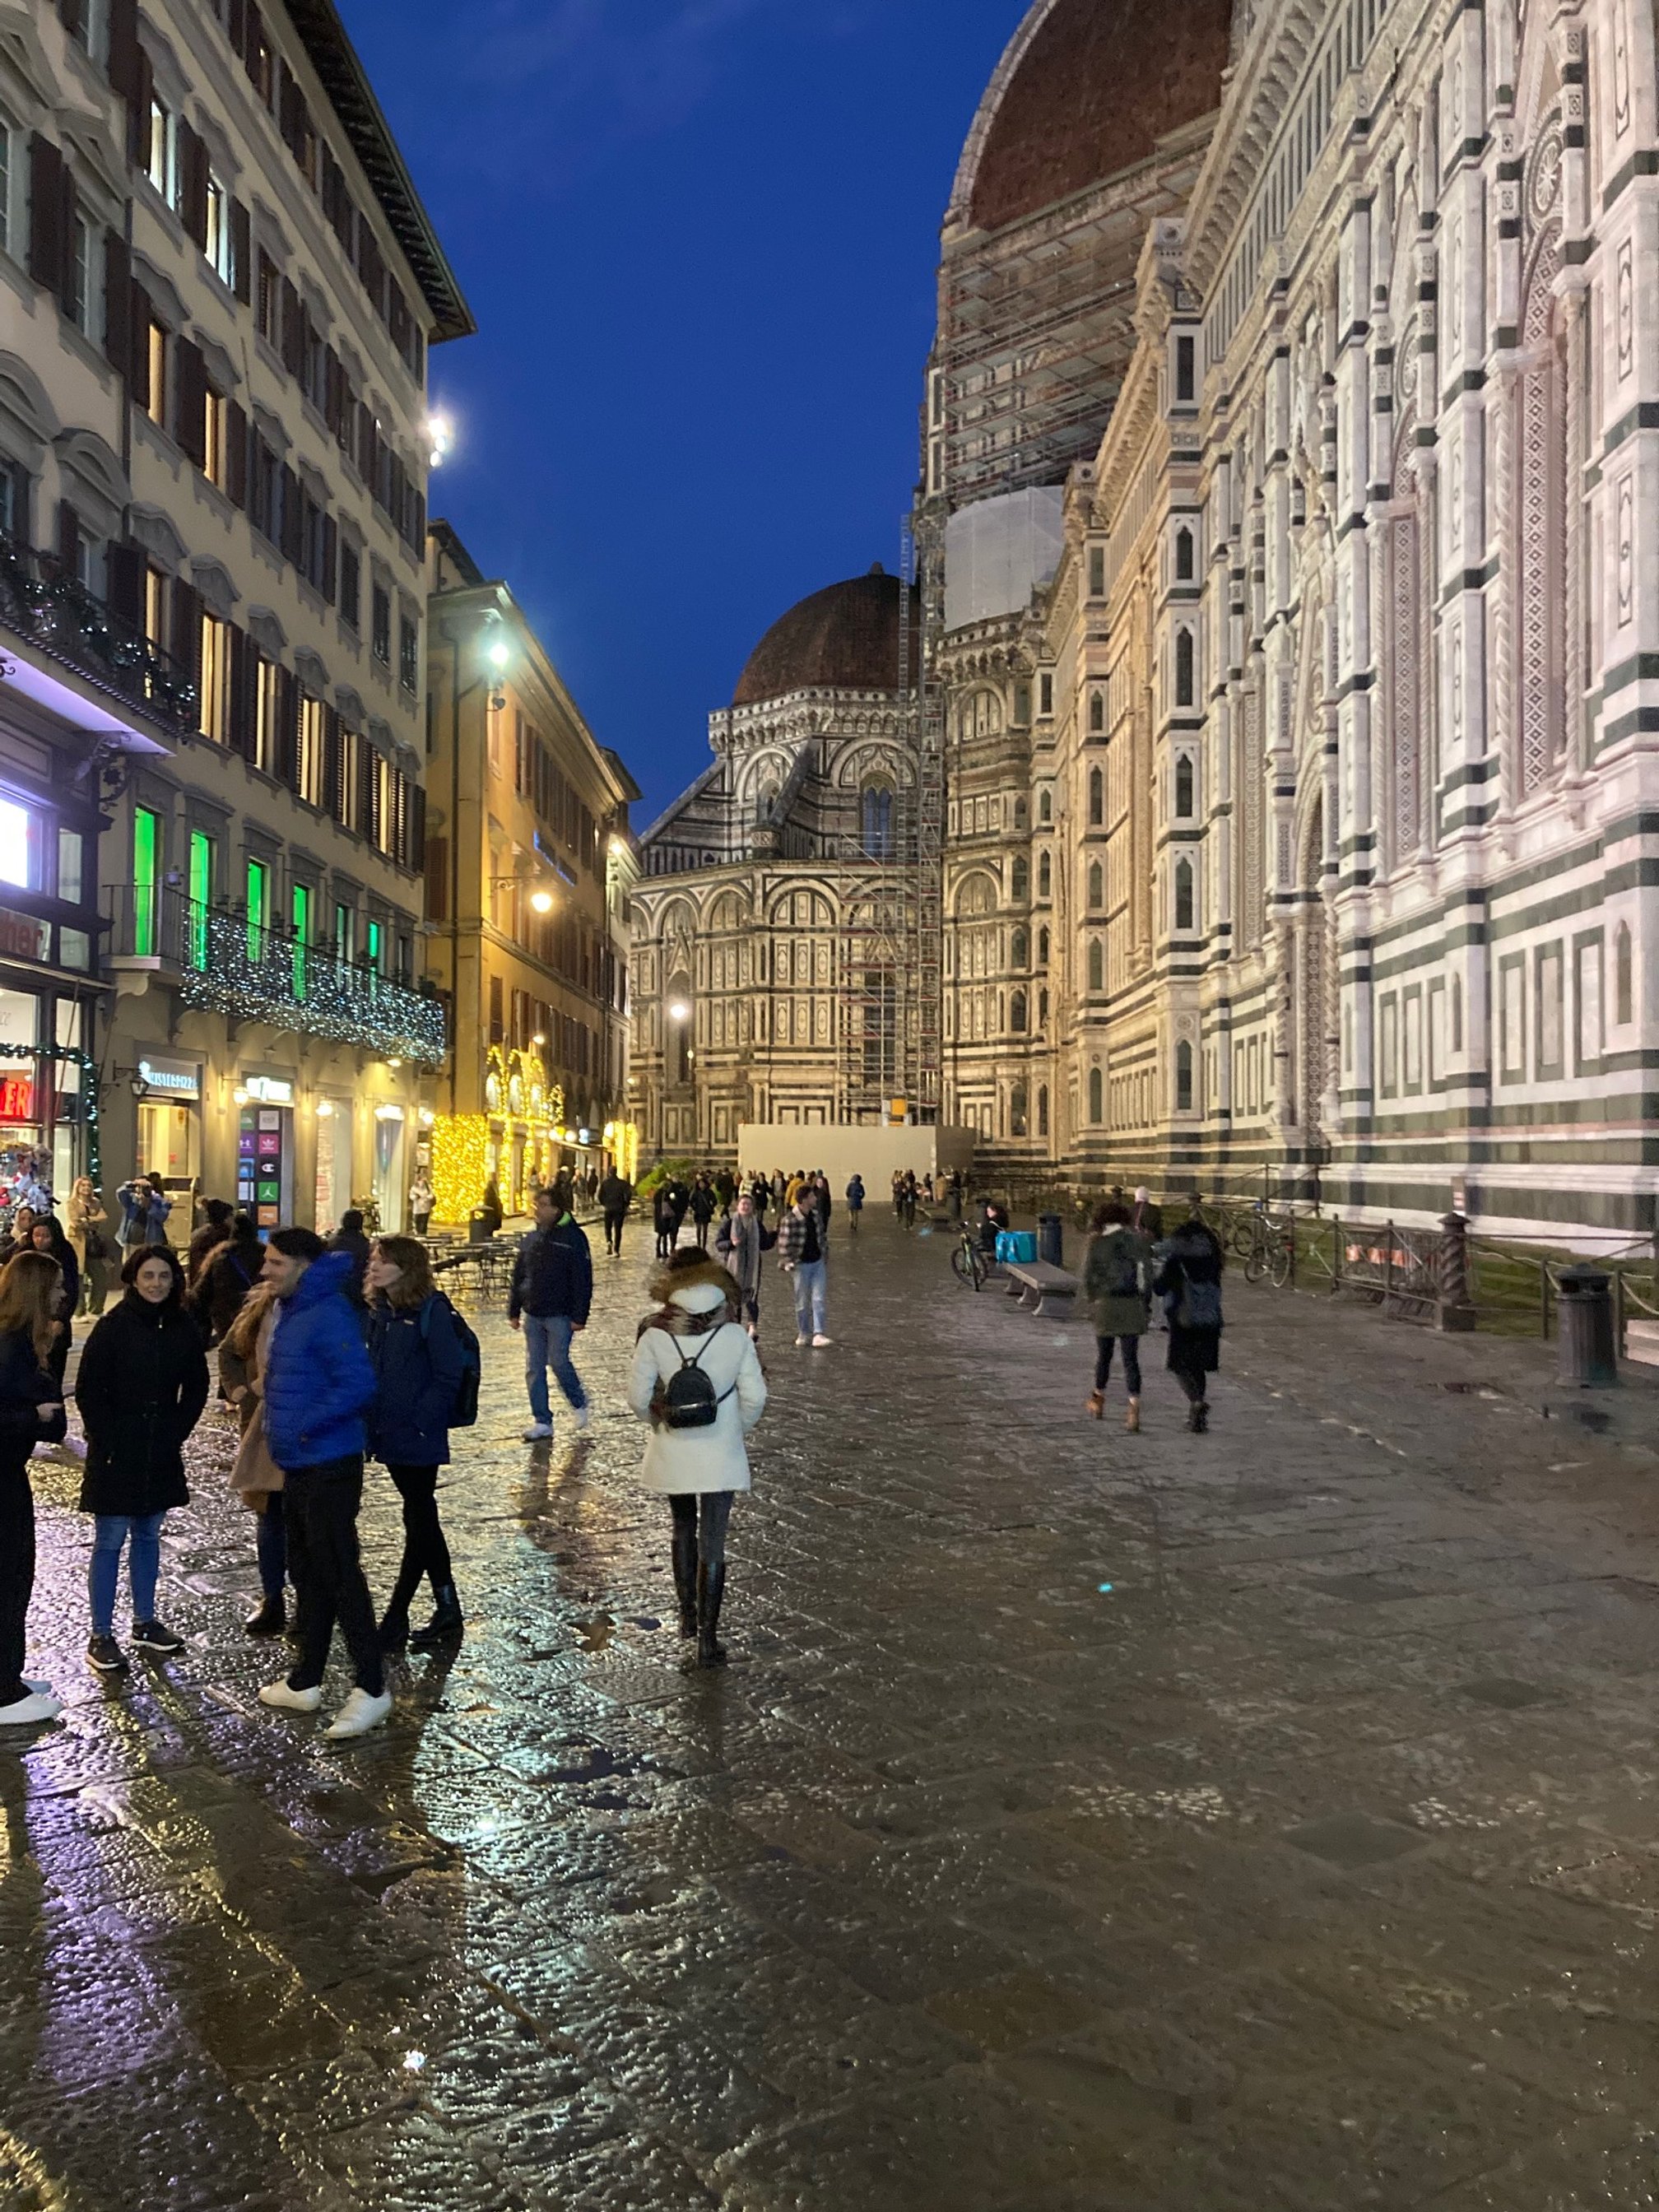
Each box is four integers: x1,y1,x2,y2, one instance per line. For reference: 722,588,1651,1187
75,1245,208,1675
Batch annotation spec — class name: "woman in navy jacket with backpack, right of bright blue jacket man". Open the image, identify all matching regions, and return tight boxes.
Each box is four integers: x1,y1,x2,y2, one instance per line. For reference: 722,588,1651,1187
365,1237,478,1652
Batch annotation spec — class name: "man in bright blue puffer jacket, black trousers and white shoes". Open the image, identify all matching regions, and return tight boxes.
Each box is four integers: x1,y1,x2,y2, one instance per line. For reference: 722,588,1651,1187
258,1230,392,1740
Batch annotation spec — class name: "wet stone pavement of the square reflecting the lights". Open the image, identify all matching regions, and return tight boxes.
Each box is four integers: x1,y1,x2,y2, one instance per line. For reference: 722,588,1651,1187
0,1221,1659,2212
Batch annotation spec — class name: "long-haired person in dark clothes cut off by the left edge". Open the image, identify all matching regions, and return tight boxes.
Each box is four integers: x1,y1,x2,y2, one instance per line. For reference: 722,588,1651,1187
0,1252,68,1727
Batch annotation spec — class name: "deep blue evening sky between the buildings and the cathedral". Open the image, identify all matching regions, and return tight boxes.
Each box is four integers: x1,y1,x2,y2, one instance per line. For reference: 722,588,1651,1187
341,0,1025,827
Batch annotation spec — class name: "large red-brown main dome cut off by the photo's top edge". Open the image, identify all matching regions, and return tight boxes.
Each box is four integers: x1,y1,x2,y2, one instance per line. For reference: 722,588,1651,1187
951,0,1232,230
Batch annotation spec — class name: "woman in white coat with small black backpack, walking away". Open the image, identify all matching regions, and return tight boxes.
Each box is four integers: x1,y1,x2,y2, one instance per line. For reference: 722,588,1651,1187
628,1250,765,1666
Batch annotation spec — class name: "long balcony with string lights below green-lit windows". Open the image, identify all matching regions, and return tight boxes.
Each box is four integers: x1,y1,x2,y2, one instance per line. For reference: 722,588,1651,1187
104,883,447,1068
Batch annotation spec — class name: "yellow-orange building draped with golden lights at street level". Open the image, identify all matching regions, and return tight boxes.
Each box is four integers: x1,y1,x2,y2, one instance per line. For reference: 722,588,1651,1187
427,522,639,1221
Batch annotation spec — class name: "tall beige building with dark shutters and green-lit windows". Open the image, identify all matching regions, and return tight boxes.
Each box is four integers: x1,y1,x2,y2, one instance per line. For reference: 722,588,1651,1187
0,0,473,1225
